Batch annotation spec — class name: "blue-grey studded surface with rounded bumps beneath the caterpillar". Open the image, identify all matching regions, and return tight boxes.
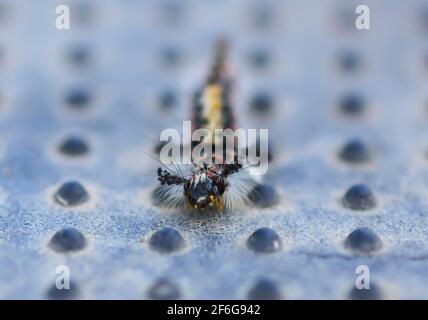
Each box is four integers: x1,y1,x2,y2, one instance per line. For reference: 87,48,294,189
0,0,428,299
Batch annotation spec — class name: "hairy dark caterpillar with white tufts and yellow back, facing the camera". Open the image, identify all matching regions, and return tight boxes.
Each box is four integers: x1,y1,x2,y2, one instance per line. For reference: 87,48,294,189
156,40,257,212
